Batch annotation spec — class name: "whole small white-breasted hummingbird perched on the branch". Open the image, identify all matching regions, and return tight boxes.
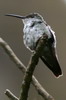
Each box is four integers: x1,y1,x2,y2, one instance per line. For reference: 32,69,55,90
6,13,62,78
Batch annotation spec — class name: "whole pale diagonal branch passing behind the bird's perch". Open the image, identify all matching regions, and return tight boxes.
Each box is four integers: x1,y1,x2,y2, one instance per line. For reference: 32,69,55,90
0,38,54,100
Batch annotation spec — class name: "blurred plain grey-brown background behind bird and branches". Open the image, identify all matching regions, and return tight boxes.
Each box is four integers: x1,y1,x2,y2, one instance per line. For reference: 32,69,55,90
0,0,66,100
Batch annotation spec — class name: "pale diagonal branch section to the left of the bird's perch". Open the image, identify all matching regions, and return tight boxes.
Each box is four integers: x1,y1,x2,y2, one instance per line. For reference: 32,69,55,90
0,38,26,73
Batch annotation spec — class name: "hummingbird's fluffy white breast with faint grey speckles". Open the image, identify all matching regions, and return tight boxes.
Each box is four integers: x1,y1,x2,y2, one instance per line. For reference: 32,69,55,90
23,23,55,50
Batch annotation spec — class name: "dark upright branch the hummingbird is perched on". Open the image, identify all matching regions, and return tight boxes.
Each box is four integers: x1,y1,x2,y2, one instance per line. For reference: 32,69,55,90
19,35,51,100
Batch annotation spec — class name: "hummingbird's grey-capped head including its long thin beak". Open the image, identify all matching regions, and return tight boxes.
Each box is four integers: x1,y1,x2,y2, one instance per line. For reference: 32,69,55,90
6,13,44,24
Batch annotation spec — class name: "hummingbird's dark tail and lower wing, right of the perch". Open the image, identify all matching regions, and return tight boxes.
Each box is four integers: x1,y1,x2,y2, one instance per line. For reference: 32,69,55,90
40,42,62,77
